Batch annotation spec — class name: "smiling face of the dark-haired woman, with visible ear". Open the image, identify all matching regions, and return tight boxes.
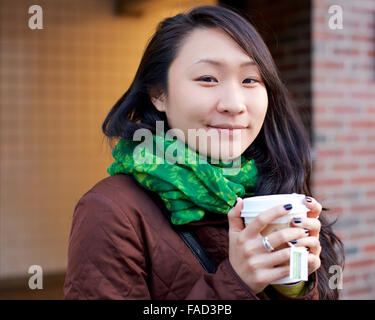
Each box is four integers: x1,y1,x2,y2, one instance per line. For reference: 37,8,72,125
152,28,268,161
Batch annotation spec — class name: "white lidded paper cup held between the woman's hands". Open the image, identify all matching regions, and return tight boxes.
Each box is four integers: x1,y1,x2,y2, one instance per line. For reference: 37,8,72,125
241,193,309,284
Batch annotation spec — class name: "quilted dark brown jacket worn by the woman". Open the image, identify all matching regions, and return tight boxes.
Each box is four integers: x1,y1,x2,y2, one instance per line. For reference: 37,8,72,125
64,174,318,300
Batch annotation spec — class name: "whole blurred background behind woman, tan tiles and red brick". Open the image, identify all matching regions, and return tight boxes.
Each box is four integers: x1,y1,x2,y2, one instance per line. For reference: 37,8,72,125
0,0,375,299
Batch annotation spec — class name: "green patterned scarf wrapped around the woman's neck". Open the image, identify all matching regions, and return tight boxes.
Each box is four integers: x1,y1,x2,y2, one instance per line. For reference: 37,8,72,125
107,135,258,225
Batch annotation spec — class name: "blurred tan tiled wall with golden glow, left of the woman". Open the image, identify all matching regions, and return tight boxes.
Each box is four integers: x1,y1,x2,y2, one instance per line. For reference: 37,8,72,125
0,0,215,279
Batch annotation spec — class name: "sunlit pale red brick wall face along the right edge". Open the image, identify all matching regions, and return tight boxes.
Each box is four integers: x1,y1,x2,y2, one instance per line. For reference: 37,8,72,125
312,0,375,299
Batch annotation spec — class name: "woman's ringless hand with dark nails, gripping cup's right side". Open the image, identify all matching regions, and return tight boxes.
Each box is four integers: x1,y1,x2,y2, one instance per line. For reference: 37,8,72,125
291,197,322,275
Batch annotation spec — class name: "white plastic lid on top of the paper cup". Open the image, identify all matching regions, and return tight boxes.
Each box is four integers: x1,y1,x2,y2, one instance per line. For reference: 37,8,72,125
241,193,309,217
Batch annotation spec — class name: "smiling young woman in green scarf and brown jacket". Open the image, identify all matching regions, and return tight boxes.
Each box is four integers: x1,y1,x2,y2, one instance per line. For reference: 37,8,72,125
64,6,343,300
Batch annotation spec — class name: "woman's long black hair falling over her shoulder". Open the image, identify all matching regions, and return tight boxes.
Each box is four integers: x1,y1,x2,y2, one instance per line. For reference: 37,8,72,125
102,6,344,299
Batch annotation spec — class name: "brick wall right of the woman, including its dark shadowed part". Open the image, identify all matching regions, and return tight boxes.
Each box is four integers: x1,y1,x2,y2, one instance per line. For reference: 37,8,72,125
246,0,375,299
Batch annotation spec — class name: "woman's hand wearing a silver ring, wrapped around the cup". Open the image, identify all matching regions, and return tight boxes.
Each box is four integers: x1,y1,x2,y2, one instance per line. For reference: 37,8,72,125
228,198,308,294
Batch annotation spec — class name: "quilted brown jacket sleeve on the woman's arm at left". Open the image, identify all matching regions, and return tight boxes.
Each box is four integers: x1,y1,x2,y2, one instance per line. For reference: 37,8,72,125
63,193,150,300
